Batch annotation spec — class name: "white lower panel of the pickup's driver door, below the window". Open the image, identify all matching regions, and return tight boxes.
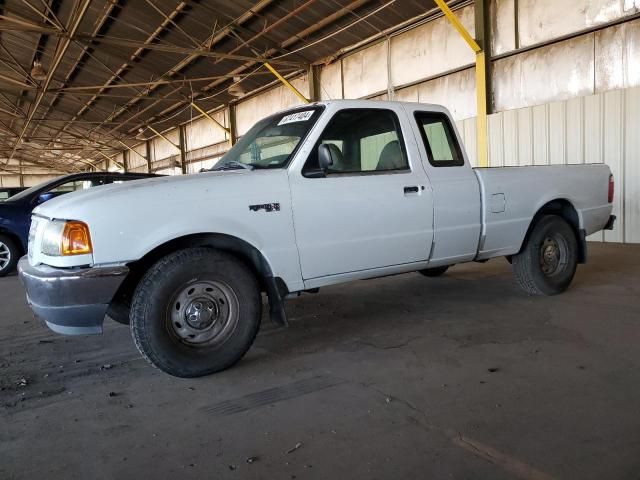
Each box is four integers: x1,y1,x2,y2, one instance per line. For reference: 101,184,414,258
292,173,432,280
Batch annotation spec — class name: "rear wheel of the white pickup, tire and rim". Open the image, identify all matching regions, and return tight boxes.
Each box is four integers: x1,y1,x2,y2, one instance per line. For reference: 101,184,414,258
512,215,578,295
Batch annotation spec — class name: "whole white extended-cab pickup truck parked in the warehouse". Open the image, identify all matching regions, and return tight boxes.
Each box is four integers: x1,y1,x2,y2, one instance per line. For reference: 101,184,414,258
19,100,615,377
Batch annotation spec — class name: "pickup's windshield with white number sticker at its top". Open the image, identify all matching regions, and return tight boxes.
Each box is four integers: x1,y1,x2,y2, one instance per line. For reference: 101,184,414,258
212,107,323,170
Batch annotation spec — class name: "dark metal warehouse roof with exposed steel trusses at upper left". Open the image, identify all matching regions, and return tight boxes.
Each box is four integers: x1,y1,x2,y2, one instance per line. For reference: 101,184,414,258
0,0,435,171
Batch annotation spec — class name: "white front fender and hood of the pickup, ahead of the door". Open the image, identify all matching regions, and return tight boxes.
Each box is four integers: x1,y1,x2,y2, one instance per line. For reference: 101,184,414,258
35,169,294,266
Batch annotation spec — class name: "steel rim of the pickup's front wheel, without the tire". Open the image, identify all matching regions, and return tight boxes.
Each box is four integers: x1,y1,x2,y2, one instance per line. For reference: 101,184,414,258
167,280,239,348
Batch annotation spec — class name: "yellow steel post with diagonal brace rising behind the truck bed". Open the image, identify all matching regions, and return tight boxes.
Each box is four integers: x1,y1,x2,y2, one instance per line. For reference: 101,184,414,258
436,0,489,167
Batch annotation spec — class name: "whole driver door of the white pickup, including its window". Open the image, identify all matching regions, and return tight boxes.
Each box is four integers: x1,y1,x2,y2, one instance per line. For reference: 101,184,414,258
290,108,433,280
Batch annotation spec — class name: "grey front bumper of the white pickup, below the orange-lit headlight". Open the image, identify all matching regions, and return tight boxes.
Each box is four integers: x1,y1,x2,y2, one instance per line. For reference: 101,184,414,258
18,256,129,335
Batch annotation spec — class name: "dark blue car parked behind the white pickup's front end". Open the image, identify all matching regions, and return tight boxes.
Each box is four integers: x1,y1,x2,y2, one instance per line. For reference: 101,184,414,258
0,172,157,277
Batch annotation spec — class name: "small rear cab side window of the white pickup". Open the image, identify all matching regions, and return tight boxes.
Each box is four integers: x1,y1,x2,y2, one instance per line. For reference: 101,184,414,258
415,112,464,167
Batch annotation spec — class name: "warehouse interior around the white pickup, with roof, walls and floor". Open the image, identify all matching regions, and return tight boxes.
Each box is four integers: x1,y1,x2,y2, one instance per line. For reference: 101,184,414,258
0,0,640,480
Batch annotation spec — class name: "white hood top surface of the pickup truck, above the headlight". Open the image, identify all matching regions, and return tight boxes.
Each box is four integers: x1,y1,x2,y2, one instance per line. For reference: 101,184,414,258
33,170,256,220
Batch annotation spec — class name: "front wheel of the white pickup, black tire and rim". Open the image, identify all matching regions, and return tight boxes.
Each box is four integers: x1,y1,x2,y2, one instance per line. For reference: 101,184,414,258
130,248,262,378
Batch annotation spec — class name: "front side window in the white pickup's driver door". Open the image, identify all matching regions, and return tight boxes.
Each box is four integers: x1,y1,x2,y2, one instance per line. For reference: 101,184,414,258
303,109,409,174
